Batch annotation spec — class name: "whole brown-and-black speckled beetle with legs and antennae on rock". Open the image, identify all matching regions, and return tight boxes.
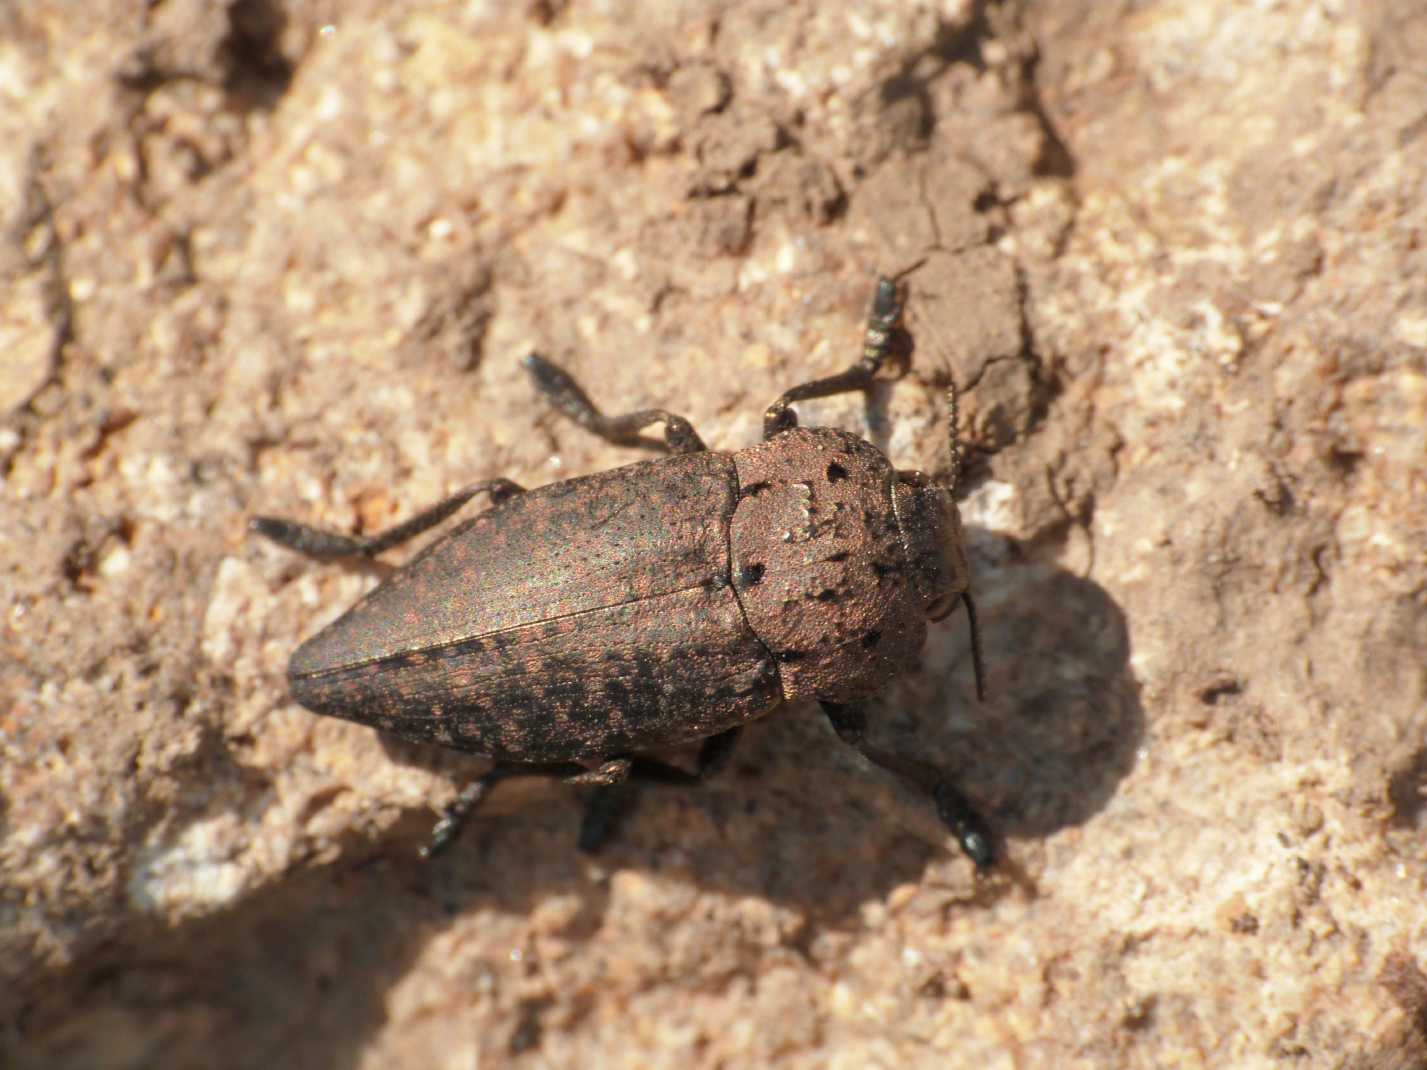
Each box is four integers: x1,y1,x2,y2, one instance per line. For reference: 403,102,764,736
251,277,995,869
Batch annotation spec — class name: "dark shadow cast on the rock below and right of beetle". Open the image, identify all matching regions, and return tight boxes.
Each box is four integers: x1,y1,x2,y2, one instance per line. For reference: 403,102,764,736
20,531,1143,1069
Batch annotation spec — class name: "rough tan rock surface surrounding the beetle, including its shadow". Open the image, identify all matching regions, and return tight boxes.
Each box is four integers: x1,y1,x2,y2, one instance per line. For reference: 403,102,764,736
0,0,1427,1067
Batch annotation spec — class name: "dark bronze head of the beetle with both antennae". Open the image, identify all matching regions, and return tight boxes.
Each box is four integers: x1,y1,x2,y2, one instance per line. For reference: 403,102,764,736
892,384,985,695
